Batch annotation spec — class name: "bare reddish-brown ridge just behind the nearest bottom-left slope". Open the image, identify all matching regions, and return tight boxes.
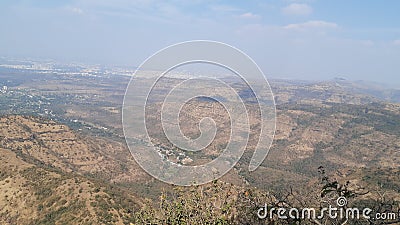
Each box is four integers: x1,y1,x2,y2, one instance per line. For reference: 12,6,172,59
0,116,147,182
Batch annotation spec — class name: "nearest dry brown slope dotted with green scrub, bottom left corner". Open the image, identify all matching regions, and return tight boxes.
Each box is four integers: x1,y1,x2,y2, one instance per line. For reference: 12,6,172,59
0,149,140,224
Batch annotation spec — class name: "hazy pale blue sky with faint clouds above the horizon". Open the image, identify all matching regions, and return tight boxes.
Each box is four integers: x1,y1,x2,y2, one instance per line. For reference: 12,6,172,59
0,0,400,87
